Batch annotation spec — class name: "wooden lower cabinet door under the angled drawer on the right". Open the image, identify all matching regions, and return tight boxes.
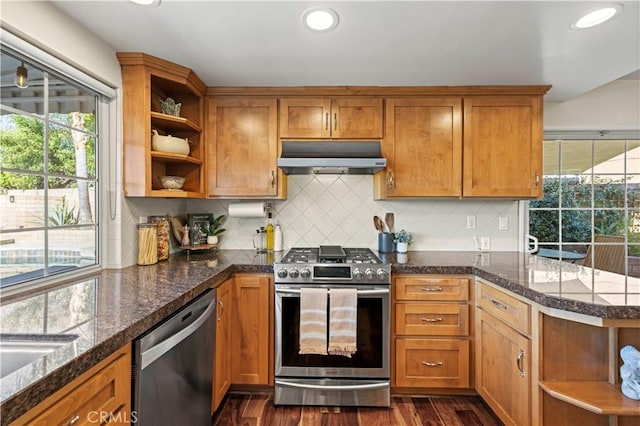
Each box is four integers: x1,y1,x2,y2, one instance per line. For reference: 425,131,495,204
476,309,531,426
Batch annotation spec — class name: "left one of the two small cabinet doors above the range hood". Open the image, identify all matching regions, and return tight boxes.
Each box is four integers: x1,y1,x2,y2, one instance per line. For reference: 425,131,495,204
280,98,331,139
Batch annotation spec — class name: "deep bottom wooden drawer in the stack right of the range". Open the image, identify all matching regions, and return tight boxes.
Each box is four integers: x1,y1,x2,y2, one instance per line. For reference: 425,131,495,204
396,338,469,388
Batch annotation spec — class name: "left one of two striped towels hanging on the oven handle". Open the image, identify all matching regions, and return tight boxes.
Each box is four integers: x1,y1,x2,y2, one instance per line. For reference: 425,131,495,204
299,288,327,355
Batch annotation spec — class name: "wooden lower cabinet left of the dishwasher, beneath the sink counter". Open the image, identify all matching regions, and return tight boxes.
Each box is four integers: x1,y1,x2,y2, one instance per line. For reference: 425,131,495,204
12,344,131,426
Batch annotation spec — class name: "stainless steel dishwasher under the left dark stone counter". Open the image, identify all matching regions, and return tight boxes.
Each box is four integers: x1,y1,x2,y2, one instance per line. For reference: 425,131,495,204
131,289,216,426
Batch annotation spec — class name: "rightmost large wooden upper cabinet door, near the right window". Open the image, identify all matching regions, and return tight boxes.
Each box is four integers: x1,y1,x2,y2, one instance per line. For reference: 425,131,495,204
463,96,542,198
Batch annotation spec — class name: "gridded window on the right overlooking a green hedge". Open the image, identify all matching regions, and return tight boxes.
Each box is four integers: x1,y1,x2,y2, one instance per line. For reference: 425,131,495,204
529,138,640,277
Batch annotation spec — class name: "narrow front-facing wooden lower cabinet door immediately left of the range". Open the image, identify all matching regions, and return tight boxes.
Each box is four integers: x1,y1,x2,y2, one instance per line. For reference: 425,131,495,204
231,274,273,385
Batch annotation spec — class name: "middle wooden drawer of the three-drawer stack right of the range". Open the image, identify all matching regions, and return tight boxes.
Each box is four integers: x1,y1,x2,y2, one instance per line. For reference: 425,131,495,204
396,303,469,336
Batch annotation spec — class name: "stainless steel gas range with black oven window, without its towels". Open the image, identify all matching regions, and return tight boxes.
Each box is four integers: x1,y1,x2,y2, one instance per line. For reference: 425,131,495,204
274,246,391,406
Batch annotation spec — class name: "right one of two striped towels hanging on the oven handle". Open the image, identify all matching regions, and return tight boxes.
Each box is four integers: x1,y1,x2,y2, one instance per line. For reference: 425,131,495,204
328,288,358,358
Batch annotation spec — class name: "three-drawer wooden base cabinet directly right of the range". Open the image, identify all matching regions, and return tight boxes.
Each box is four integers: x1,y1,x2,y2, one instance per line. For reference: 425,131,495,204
392,274,472,389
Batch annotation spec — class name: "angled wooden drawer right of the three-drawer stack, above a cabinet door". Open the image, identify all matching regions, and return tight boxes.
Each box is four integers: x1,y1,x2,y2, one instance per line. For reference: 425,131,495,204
478,284,531,335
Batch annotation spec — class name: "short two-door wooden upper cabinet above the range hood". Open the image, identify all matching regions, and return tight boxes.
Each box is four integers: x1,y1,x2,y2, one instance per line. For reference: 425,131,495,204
280,97,383,139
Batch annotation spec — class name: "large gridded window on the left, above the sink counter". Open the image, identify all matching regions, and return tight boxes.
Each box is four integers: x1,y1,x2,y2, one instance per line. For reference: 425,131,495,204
0,46,100,289
